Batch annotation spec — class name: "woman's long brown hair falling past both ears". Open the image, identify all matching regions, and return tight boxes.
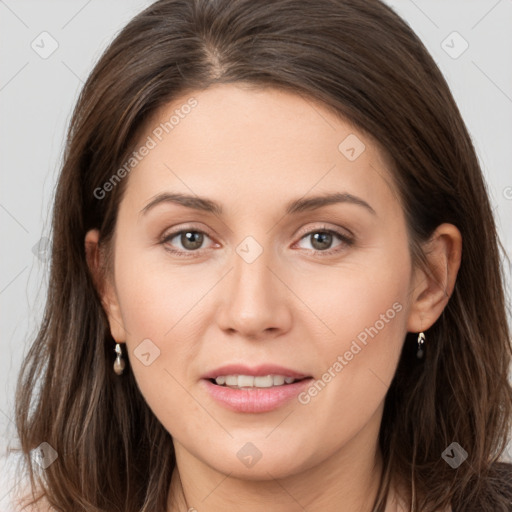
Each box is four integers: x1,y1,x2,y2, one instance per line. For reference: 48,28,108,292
12,0,512,512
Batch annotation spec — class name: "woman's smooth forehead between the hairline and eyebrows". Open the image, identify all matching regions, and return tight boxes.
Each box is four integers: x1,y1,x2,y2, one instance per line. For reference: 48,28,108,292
121,84,396,218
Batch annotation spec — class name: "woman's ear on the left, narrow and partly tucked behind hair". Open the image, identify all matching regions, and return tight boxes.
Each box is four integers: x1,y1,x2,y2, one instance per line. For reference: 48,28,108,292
85,229,126,343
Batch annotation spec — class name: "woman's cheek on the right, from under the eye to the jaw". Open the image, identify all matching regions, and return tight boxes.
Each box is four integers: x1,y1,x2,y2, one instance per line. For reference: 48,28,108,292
299,251,409,439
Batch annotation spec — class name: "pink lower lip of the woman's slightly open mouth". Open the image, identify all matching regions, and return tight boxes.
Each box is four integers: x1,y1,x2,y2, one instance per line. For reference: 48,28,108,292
202,378,312,413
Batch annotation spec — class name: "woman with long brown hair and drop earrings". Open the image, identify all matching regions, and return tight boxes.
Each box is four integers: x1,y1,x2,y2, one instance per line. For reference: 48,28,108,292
11,0,512,512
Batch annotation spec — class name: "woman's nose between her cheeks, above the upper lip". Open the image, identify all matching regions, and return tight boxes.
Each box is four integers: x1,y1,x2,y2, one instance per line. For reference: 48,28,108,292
217,242,293,340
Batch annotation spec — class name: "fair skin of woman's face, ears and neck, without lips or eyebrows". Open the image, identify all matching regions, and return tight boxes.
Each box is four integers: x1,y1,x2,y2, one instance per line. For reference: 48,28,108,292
85,84,461,512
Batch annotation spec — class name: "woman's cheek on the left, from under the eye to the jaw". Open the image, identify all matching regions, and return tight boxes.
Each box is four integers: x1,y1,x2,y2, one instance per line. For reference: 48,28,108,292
115,247,212,434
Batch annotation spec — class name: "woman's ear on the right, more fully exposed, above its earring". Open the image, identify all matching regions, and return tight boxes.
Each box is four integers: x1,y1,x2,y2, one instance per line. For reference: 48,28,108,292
407,224,462,332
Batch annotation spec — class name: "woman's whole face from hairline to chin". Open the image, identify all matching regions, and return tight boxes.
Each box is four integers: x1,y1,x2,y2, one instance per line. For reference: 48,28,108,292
95,85,415,479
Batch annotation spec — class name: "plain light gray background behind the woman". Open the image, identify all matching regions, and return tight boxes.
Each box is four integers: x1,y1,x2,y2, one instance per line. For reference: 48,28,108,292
0,0,512,504
